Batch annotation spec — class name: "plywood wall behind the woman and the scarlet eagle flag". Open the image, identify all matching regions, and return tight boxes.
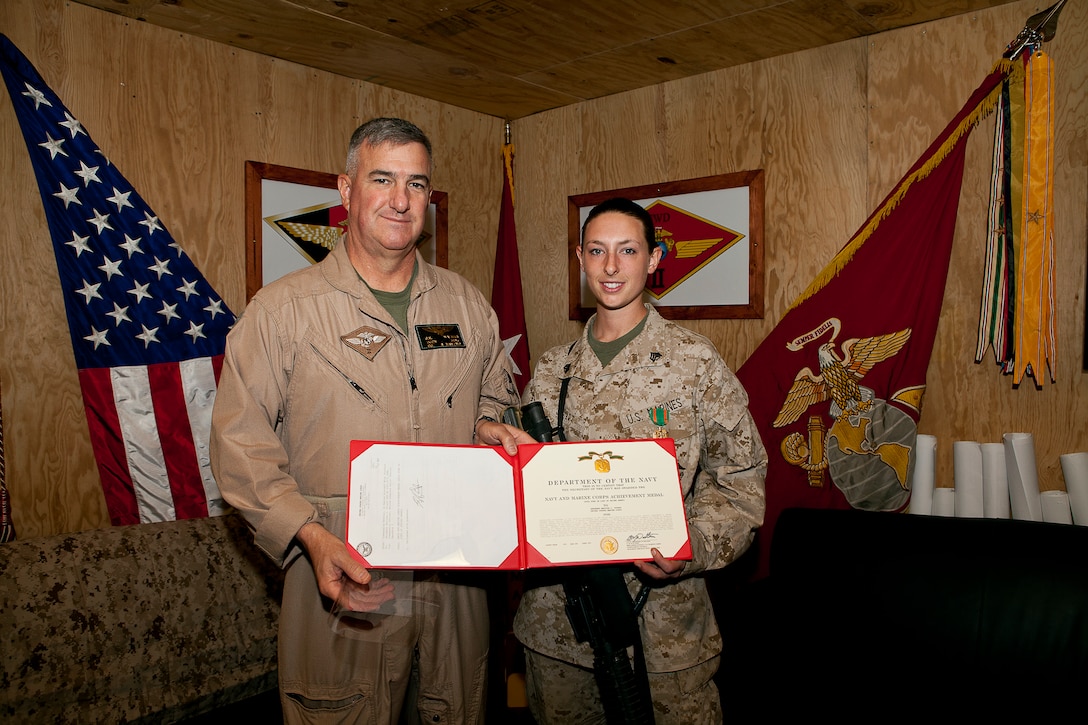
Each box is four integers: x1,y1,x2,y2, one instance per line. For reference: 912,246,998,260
514,2,1088,496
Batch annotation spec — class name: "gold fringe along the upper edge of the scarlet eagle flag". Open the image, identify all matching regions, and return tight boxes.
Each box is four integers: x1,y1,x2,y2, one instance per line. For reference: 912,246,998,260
787,58,1024,311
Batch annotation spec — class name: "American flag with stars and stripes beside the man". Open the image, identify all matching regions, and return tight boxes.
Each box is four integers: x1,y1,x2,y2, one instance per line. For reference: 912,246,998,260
0,35,235,525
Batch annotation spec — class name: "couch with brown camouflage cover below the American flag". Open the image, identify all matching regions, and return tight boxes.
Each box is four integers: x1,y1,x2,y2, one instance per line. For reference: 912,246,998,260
0,515,283,724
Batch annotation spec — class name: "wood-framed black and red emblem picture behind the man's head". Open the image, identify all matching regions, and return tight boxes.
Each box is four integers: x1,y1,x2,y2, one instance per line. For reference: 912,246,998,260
246,161,449,303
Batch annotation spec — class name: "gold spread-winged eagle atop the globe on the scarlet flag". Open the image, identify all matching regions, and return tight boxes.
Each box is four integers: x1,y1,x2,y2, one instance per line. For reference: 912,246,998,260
772,328,911,428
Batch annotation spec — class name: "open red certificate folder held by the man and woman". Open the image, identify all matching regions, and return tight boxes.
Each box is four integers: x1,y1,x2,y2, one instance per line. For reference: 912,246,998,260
347,439,691,569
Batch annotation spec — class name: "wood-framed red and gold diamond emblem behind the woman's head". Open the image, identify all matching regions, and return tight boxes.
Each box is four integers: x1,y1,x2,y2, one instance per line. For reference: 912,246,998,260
567,169,764,321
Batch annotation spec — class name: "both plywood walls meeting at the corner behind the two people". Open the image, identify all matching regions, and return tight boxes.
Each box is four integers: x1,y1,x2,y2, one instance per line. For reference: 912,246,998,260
0,0,1088,538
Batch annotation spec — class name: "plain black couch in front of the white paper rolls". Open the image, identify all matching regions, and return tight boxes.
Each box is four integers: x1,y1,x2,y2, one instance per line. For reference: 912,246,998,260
719,509,1088,721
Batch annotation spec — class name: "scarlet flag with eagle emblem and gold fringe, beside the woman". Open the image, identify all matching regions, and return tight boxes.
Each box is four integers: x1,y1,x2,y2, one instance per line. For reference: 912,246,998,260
738,62,1012,576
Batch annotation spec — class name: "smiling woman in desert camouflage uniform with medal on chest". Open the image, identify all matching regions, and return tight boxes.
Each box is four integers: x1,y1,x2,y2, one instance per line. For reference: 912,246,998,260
515,199,767,725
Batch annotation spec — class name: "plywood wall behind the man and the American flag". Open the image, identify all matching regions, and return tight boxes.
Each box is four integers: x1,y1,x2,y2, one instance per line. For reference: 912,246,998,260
0,0,503,538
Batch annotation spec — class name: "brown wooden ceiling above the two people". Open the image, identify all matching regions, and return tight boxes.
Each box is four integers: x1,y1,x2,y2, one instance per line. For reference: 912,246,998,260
65,0,1026,119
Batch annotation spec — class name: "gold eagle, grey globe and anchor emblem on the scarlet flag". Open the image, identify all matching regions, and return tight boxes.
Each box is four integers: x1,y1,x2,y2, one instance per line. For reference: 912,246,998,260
772,318,925,511
